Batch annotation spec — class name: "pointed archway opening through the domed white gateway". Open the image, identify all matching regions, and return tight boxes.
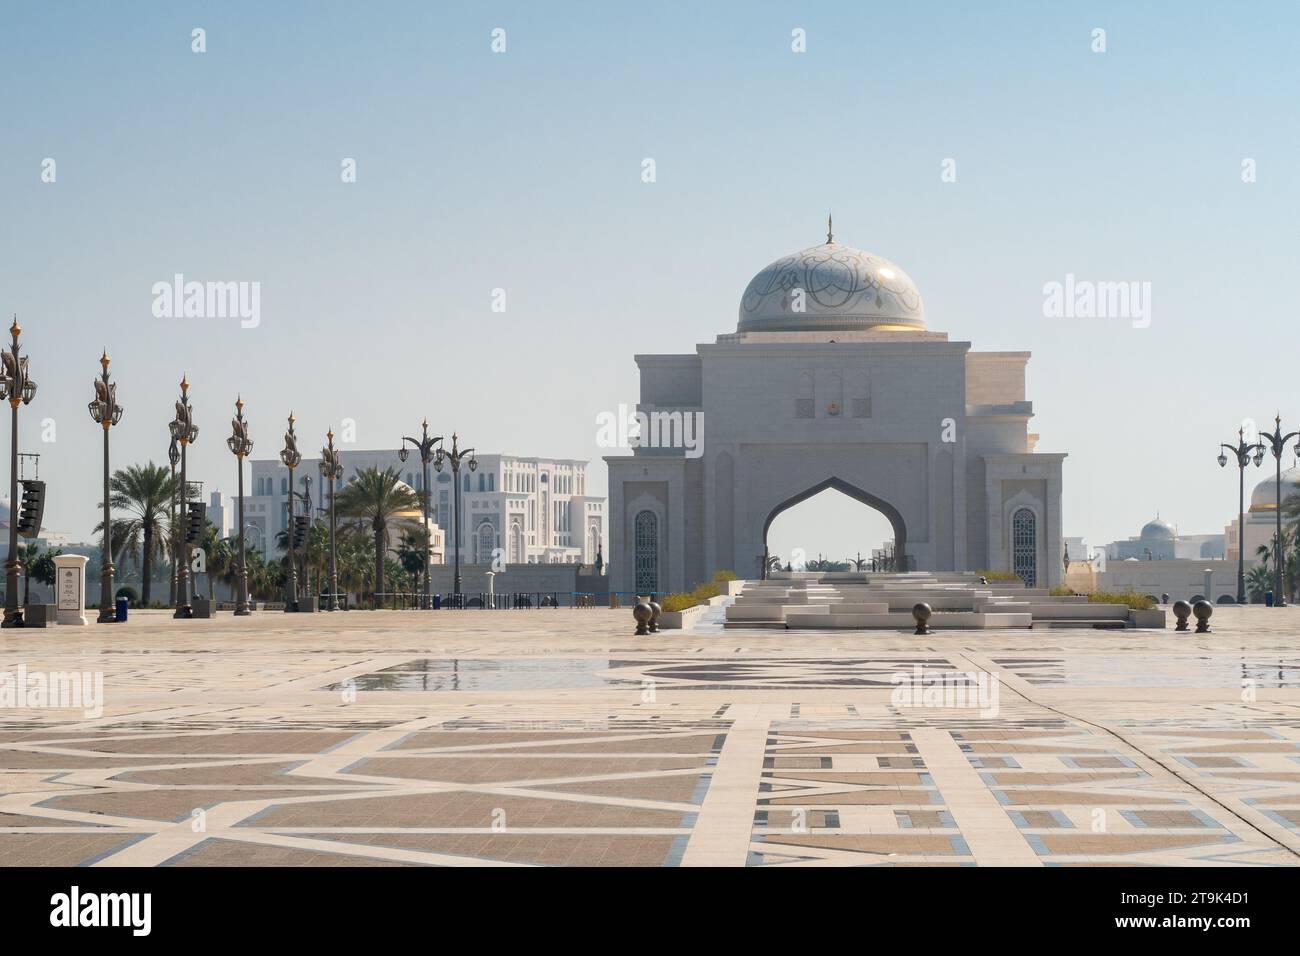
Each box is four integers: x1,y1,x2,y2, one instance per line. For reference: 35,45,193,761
763,477,910,571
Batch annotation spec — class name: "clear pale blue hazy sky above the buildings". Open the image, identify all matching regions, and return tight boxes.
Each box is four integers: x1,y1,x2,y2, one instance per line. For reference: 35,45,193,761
0,0,1300,554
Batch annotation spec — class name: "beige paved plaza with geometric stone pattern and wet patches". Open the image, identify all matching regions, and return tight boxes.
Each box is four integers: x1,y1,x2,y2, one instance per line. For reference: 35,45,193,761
0,607,1300,866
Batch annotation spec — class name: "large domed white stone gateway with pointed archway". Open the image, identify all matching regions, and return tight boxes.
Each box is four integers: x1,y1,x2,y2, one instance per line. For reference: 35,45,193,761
605,233,1065,593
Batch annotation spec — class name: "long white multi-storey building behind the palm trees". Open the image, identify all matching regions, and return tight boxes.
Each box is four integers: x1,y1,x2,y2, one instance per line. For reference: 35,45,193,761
240,449,605,564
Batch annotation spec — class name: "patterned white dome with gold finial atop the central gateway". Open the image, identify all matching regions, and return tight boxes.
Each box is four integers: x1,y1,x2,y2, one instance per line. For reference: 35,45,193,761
736,235,926,332
